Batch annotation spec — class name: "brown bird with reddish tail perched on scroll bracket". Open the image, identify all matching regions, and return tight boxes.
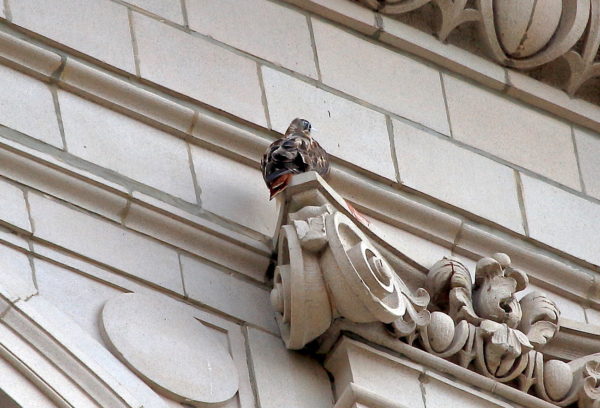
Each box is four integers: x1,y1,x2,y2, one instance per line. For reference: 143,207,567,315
260,118,329,199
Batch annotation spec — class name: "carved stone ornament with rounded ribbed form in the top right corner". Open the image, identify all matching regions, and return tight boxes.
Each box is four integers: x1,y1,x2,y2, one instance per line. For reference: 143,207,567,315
359,0,600,95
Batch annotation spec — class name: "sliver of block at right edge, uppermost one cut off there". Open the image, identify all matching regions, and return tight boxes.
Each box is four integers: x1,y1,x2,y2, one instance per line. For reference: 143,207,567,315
573,128,600,199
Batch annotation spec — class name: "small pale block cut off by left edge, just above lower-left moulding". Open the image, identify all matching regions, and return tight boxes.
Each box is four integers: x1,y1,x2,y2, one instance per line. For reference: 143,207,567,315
0,245,37,299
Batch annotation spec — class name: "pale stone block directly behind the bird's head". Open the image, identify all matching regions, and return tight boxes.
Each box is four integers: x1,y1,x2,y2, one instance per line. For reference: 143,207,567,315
263,67,396,180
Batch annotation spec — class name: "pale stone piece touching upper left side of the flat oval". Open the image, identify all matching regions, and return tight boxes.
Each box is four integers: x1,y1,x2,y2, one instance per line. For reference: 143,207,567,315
34,259,123,342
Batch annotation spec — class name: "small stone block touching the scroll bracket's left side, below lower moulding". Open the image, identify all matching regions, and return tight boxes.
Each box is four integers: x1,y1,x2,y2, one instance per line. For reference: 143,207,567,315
181,255,277,332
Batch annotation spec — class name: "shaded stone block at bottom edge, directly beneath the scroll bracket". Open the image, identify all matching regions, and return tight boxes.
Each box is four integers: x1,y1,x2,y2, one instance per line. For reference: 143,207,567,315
248,328,333,408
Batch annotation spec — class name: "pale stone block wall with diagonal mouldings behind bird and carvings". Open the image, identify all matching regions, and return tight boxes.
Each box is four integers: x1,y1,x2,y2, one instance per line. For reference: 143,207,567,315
0,0,600,408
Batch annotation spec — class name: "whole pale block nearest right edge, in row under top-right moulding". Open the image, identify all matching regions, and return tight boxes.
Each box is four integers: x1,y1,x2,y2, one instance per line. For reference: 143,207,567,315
443,75,580,189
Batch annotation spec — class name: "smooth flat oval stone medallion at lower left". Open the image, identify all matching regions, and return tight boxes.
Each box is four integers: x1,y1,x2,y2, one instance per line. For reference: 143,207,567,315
102,293,239,405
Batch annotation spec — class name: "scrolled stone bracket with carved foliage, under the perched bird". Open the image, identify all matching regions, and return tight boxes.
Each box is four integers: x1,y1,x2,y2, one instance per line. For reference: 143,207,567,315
271,174,600,408
